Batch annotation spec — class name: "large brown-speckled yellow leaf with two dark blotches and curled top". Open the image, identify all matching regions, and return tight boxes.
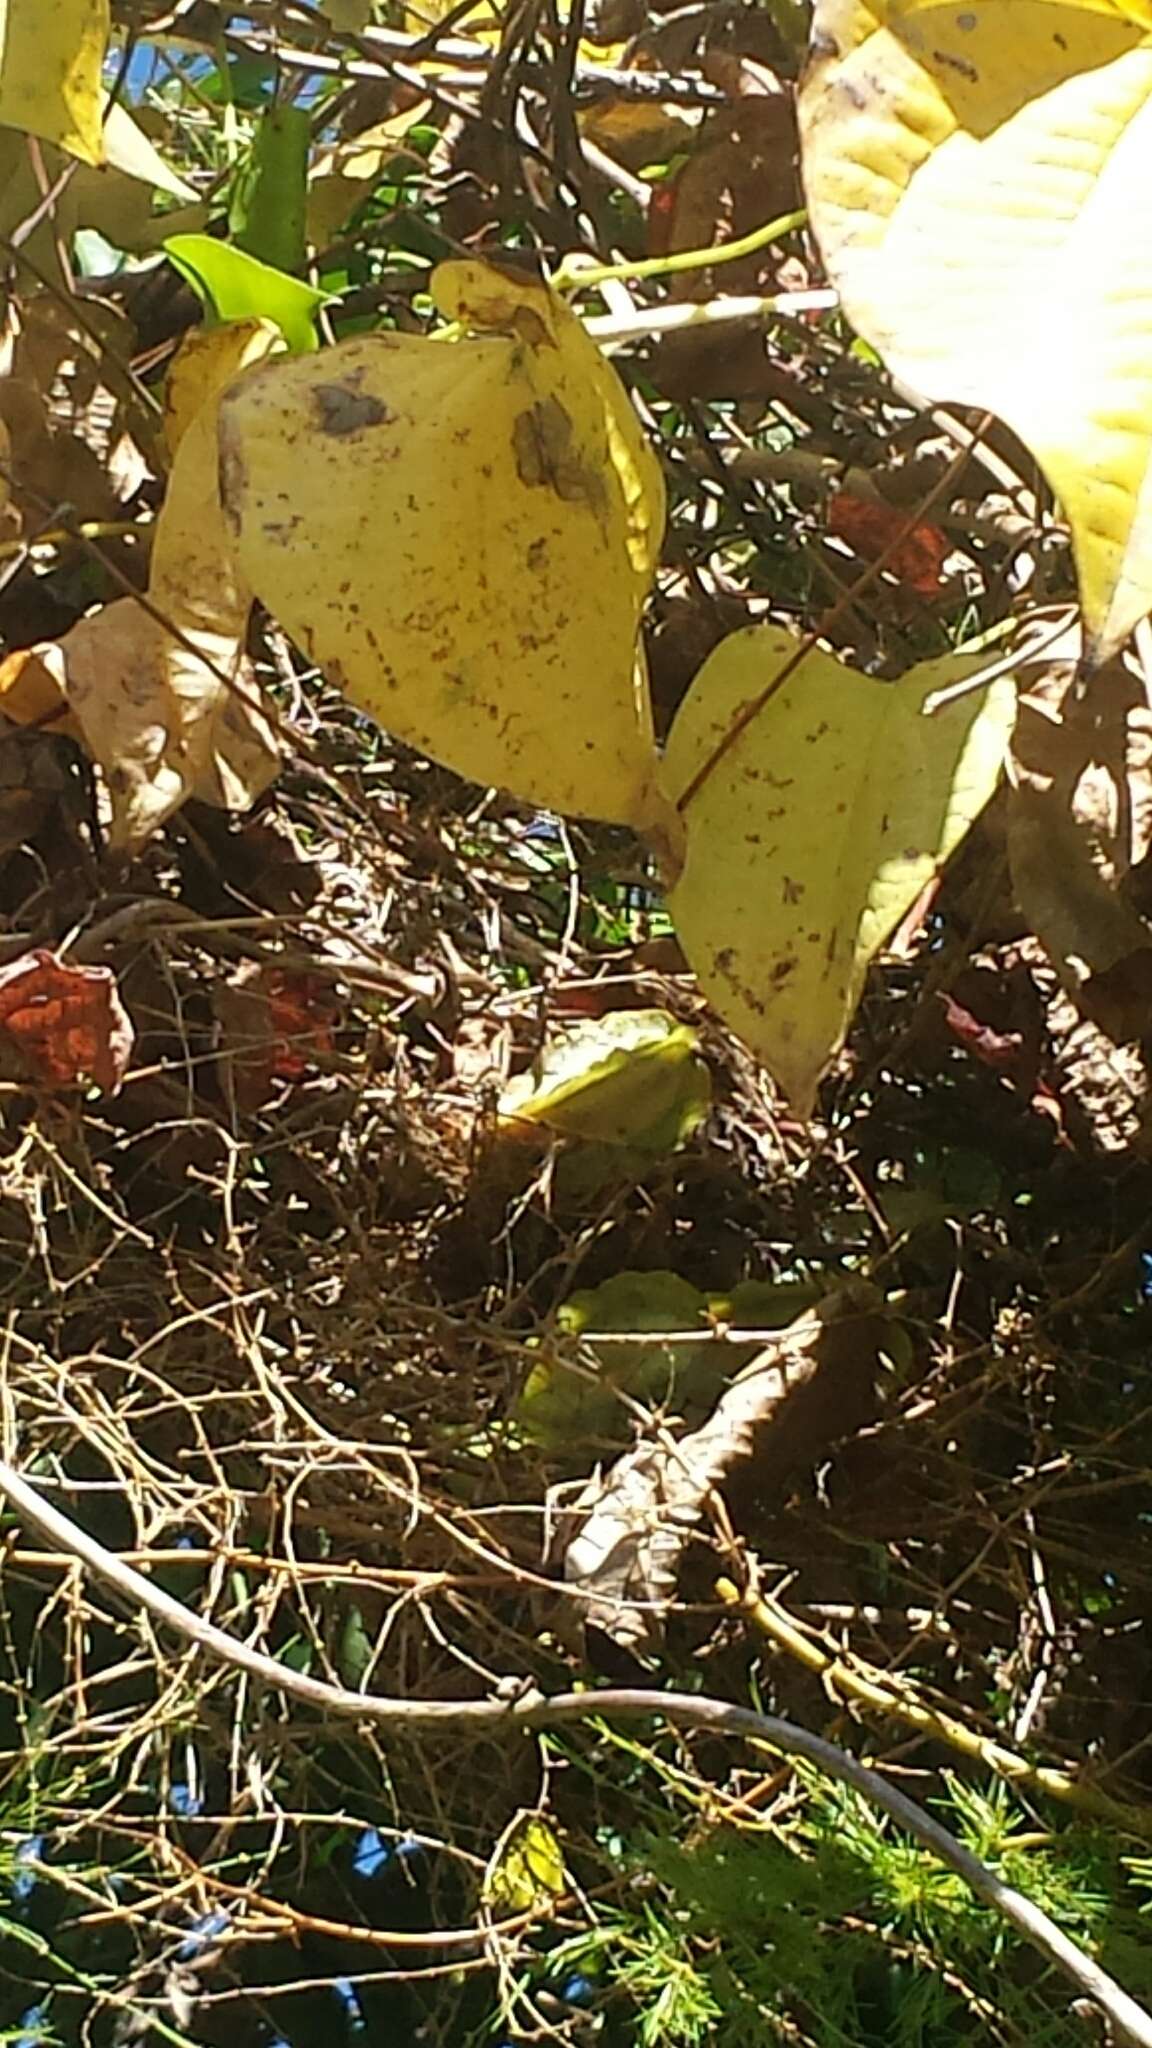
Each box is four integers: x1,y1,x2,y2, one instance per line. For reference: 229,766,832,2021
221,262,664,829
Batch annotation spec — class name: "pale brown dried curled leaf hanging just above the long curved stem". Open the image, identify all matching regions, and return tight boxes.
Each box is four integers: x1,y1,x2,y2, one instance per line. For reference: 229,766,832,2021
564,1282,883,1657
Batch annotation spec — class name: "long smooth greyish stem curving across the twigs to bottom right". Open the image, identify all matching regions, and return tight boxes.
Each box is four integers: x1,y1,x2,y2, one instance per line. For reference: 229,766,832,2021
0,1462,1152,2048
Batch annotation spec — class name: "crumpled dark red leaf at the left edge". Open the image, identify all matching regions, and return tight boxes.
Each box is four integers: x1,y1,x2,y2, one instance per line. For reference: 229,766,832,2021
0,952,135,1096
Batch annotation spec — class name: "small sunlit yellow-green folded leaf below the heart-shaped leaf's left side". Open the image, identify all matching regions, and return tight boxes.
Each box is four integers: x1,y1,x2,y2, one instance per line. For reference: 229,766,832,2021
500,1010,711,1153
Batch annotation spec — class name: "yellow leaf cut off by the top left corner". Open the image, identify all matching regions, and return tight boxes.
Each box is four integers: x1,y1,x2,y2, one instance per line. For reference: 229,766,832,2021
0,0,111,164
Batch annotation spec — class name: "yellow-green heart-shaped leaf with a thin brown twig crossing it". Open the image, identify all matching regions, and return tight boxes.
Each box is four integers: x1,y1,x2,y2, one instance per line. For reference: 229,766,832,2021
664,627,1015,1116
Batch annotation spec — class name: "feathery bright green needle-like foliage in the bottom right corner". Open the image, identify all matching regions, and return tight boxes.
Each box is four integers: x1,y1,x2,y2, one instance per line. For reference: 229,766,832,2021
522,1772,1152,2048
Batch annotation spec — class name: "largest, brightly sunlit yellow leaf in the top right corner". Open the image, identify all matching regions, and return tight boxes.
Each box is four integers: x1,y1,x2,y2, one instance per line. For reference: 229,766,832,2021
801,0,1152,664
